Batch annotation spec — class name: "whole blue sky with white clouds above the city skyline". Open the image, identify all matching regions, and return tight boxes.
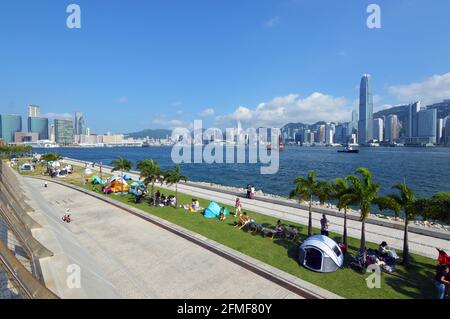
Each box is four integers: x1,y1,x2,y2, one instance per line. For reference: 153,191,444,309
0,0,450,133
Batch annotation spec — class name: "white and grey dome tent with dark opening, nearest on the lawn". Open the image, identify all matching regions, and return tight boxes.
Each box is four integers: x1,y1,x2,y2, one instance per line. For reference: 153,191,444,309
299,235,344,273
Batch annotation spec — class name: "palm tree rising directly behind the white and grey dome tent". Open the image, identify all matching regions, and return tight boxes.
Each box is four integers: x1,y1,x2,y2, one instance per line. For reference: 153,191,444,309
289,171,326,237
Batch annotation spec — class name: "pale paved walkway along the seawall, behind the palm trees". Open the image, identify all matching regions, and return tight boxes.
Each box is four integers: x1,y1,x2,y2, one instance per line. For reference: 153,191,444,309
65,160,450,258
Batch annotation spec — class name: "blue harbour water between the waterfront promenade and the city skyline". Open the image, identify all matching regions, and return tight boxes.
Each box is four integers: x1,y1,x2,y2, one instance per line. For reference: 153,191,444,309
34,146,450,197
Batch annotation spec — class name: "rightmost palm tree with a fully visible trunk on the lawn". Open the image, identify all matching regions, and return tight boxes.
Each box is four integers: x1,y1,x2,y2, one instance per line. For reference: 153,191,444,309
377,183,419,265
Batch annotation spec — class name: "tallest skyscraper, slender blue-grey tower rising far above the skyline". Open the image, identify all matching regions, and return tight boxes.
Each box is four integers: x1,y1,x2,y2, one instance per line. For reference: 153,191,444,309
358,74,373,144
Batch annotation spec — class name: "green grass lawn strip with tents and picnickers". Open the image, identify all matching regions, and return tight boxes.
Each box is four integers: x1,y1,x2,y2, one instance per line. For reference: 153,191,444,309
15,160,436,299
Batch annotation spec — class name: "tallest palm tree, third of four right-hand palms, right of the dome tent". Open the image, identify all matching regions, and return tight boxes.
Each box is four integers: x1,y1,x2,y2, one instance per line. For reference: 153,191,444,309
342,167,380,258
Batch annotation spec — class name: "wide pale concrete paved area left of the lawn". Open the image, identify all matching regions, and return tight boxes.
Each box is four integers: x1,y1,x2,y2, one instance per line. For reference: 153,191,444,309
22,178,312,299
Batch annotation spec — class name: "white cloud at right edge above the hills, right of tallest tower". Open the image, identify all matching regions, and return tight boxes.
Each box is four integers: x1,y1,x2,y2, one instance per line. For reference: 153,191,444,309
388,73,450,105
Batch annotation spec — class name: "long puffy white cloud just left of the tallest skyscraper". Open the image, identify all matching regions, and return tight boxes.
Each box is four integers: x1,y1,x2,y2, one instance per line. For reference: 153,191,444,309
216,92,352,127
